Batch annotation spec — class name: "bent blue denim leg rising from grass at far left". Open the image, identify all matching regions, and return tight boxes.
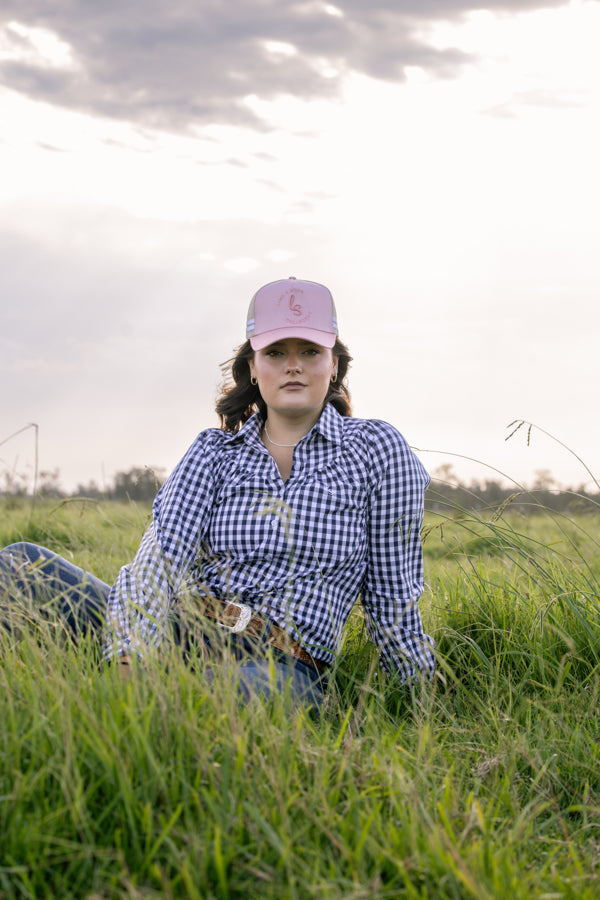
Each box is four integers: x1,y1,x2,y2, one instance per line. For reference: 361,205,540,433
0,542,110,636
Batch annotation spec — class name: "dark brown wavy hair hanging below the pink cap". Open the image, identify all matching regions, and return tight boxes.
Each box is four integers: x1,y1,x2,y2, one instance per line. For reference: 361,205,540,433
216,340,352,432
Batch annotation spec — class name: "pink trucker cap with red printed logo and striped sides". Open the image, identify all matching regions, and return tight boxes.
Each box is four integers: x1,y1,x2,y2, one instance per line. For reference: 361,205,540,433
246,277,338,350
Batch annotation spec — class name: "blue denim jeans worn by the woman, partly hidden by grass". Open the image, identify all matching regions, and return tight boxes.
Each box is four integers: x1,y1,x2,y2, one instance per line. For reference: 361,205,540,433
0,542,326,709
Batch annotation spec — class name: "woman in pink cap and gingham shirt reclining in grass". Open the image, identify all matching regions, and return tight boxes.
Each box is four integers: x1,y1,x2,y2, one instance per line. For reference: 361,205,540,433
0,278,433,704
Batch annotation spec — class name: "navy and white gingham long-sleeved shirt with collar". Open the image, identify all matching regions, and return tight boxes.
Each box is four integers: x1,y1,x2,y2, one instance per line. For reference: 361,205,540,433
105,405,433,677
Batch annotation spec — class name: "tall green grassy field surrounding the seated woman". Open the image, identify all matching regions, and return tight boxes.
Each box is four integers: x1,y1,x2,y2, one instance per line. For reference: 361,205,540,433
0,501,600,900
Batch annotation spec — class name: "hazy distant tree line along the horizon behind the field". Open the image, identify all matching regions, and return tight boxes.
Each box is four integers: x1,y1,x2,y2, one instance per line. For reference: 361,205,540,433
0,465,600,516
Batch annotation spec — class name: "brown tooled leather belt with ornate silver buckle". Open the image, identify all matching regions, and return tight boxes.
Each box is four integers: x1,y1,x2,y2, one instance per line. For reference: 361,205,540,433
199,597,329,672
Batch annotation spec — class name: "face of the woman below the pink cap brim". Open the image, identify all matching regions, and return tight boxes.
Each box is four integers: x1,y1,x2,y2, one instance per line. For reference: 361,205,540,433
249,338,338,421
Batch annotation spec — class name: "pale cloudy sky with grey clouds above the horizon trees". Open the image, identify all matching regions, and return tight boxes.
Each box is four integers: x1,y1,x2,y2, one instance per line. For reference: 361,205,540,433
0,0,600,489
